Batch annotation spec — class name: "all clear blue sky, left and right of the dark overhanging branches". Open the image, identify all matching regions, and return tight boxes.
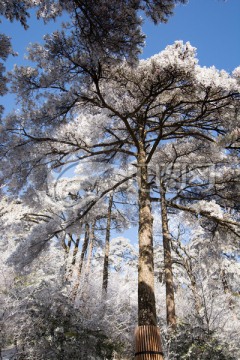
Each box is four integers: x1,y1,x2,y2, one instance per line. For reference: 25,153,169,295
0,0,240,112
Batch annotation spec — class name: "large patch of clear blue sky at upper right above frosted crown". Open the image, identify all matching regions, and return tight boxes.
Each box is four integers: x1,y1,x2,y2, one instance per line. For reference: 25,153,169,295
143,0,240,72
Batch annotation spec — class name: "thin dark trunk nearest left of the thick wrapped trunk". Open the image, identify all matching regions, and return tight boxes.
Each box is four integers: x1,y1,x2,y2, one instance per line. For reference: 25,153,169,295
102,193,113,295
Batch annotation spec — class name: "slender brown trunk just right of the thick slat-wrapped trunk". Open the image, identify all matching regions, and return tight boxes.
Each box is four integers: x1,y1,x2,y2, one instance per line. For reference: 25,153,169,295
160,180,177,330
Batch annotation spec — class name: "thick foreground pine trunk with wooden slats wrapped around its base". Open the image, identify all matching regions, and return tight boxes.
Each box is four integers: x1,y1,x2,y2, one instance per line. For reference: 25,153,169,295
135,143,163,360
